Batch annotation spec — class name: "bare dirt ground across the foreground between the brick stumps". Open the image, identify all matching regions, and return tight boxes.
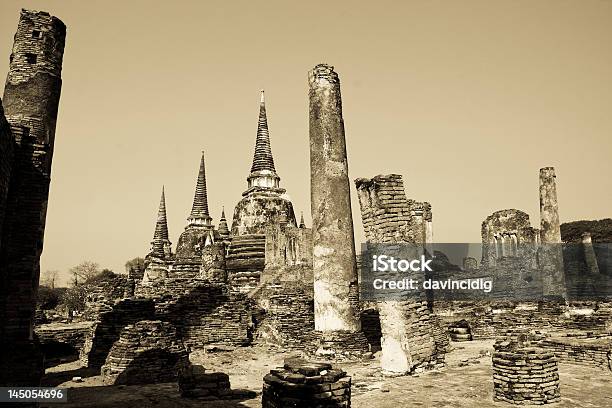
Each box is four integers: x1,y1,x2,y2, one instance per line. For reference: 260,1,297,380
43,341,612,408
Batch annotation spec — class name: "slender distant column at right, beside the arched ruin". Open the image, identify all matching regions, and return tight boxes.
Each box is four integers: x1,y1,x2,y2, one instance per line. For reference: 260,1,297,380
539,167,567,300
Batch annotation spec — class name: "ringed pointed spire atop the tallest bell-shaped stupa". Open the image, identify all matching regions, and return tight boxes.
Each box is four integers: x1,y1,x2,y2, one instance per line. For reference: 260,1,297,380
247,90,280,188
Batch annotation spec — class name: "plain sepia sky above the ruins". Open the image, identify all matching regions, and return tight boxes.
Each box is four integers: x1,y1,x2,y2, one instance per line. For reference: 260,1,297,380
0,0,612,286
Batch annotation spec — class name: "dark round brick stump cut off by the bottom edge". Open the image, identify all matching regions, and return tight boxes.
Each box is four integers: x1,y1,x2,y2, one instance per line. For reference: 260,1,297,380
262,360,351,408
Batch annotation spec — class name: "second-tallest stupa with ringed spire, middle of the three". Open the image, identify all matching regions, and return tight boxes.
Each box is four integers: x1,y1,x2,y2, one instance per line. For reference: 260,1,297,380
173,152,214,273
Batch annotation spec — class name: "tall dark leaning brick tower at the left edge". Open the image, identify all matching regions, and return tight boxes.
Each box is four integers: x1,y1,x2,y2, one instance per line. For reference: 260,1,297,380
0,10,66,385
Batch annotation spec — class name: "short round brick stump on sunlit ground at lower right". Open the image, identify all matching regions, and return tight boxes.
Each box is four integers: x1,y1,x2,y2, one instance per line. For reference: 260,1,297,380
493,339,561,405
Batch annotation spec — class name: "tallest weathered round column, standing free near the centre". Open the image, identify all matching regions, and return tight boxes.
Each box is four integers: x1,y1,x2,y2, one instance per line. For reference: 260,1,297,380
308,64,361,332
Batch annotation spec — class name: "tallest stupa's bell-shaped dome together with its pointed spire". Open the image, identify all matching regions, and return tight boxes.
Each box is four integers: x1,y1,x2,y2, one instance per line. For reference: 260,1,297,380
232,91,297,236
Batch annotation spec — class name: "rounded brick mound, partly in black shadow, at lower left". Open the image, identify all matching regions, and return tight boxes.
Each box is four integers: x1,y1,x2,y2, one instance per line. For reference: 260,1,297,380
101,320,189,385
